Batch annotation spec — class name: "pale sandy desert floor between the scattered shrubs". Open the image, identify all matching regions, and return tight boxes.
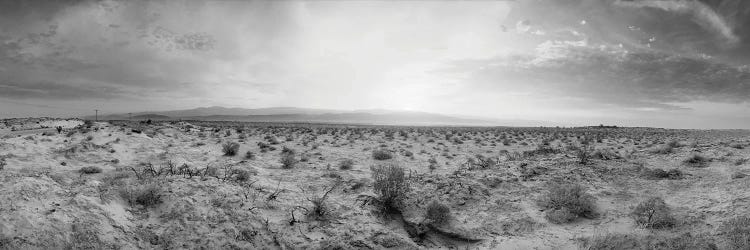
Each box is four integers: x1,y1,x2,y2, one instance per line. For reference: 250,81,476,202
0,120,750,249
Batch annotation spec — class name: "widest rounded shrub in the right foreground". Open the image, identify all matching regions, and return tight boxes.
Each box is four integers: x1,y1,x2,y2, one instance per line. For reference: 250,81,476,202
539,183,596,224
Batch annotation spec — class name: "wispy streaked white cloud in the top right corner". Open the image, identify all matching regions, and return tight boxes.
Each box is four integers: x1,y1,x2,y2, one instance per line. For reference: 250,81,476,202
505,0,750,59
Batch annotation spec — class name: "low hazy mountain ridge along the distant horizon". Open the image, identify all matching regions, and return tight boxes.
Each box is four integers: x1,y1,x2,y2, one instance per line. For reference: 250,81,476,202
85,106,560,126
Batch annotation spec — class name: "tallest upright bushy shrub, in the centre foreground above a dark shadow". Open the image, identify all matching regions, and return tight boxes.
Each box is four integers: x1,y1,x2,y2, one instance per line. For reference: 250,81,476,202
370,164,409,212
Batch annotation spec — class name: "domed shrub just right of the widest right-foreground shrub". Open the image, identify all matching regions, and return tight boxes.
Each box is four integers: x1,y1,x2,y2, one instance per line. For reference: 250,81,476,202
630,197,675,229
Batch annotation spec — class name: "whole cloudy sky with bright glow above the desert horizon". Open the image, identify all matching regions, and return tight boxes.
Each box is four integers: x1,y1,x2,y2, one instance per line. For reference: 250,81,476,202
0,0,750,128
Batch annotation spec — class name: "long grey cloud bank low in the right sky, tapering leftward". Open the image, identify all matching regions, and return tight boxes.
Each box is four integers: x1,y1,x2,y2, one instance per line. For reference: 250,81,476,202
443,41,750,110
